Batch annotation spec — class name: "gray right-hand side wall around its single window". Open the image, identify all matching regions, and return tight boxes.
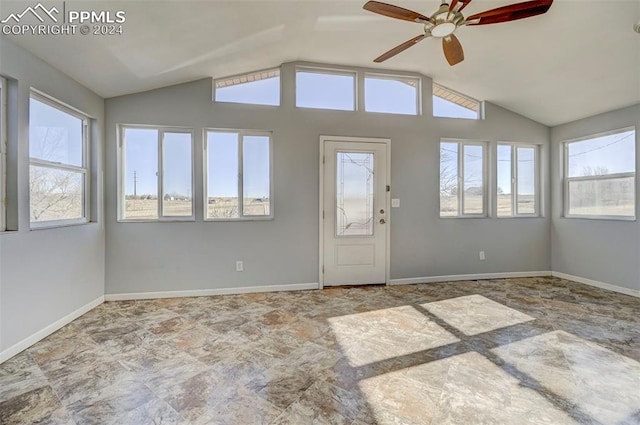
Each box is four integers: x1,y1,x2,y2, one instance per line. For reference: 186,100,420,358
551,105,640,290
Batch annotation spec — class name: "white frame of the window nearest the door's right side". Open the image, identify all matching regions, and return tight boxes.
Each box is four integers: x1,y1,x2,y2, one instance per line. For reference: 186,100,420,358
438,139,489,219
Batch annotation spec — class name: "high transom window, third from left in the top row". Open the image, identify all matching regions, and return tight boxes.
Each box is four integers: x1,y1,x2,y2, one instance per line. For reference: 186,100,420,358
364,74,420,115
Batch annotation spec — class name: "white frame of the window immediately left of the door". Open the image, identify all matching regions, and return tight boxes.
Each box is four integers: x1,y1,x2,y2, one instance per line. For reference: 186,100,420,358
202,128,274,221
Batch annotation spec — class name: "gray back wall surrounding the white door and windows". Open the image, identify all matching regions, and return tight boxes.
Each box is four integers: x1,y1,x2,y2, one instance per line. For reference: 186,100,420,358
105,64,550,294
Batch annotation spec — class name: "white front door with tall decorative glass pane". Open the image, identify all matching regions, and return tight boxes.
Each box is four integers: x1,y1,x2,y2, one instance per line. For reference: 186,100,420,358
321,138,389,286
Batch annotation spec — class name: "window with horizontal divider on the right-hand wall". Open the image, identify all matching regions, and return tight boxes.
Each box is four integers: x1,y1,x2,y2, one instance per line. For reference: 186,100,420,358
564,128,636,219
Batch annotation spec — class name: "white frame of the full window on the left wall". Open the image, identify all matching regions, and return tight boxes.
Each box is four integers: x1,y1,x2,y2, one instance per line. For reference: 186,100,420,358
29,89,91,230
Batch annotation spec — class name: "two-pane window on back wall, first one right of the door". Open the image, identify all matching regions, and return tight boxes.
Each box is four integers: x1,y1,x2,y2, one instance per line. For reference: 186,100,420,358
440,140,486,217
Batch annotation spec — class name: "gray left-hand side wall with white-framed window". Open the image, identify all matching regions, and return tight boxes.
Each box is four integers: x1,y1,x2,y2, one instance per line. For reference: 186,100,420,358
0,38,105,351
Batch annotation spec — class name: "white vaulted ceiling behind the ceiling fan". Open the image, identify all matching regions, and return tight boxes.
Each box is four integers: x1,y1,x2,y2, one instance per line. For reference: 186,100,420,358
0,0,640,126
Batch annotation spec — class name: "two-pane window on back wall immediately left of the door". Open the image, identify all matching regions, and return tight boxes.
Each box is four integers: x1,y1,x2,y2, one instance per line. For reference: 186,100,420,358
205,130,272,220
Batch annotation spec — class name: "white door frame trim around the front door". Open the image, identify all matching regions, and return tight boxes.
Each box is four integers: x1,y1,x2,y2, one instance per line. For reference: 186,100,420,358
318,135,391,289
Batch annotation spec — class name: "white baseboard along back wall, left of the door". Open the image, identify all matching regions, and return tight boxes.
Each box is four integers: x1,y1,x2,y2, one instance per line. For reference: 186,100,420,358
104,283,320,301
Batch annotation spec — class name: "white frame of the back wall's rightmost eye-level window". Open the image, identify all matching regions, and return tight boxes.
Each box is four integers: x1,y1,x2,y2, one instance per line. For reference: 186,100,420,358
495,142,542,218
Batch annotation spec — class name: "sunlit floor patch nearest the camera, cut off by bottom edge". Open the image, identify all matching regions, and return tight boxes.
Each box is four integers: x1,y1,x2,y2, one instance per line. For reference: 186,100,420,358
359,352,576,425
